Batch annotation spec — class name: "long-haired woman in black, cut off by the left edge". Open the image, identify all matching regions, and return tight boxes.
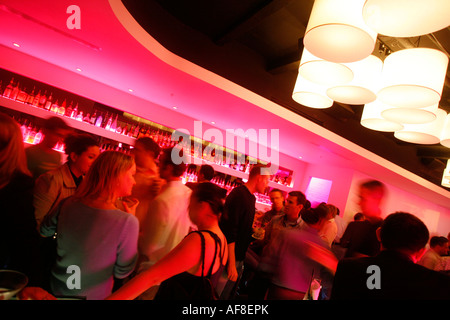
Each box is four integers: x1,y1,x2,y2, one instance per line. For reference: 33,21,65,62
0,113,40,285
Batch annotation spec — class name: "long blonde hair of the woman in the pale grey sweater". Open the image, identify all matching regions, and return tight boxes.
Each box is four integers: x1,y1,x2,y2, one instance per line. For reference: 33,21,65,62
74,151,134,199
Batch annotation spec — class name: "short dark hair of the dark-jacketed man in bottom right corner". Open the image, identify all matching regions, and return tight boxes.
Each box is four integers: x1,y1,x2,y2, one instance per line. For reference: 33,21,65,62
380,212,430,252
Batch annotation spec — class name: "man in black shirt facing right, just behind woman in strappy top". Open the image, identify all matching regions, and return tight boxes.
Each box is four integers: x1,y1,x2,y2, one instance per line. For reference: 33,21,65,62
219,165,270,299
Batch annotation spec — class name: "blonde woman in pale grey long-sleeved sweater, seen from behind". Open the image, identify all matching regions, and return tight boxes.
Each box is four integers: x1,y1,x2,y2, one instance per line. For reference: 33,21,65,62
40,151,139,300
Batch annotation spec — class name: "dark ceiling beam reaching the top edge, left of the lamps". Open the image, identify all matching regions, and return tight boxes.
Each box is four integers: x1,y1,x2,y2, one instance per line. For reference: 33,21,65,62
214,0,293,45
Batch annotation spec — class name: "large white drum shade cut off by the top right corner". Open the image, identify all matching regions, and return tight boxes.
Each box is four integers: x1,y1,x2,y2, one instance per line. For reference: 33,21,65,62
362,0,450,37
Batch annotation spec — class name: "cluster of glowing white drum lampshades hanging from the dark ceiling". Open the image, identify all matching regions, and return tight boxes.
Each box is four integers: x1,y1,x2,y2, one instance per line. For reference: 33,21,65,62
292,0,450,186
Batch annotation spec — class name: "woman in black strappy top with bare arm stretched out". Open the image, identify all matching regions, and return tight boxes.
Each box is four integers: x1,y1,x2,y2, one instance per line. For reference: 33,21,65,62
107,182,228,300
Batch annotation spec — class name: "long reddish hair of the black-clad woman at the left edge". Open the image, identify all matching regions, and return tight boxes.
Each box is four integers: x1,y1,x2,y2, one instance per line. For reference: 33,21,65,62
0,112,31,188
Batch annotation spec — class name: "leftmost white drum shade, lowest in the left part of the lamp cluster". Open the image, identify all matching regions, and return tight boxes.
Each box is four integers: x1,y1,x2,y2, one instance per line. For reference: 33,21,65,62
292,74,333,109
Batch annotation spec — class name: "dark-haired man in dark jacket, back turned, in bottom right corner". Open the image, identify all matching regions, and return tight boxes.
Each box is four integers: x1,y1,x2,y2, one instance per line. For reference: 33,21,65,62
331,212,450,300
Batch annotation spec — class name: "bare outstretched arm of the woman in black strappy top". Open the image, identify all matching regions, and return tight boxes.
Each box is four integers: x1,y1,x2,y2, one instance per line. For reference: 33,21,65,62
106,234,201,300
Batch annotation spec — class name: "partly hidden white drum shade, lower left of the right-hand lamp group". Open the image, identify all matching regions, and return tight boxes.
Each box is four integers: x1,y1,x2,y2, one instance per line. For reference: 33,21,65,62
361,100,403,132
